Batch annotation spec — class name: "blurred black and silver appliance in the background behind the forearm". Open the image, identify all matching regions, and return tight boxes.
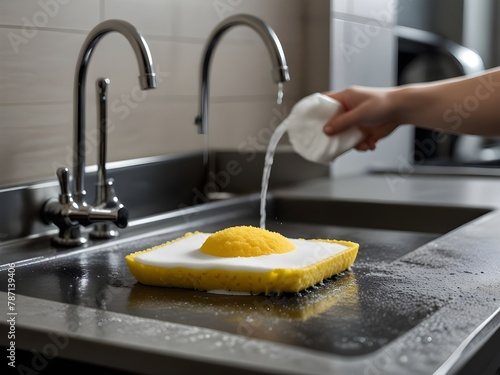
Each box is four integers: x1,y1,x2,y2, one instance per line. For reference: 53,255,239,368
400,0,500,166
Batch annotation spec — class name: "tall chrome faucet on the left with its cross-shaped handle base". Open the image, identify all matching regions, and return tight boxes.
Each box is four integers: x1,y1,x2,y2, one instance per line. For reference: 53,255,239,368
42,20,156,246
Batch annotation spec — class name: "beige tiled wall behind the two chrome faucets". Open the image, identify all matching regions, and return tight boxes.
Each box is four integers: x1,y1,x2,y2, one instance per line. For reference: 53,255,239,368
0,0,329,186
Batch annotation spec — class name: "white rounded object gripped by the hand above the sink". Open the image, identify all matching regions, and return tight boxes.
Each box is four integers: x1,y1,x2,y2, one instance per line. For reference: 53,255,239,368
285,93,363,164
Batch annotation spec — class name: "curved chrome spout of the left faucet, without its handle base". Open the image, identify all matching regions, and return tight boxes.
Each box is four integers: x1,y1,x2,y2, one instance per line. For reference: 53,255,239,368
73,20,156,204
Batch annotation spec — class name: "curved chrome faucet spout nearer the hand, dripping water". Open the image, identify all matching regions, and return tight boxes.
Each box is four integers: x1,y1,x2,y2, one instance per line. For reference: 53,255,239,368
195,14,290,134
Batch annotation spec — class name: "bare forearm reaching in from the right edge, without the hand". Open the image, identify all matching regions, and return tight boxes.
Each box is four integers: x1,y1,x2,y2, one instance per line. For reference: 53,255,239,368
389,68,500,136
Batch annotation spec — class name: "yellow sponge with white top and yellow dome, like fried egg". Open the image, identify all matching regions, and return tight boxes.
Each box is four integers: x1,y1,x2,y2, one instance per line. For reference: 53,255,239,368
125,226,359,294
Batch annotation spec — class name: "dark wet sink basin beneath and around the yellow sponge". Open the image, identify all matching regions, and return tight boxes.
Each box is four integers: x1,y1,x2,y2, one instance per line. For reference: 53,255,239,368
0,189,496,374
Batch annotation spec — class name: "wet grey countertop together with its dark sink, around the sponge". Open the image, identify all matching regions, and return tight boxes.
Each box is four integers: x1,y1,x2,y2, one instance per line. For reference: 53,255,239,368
0,173,500,374
